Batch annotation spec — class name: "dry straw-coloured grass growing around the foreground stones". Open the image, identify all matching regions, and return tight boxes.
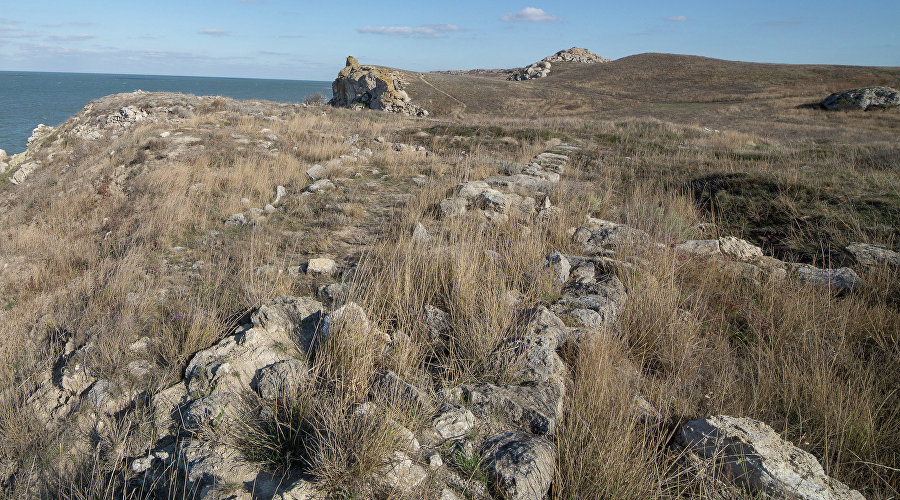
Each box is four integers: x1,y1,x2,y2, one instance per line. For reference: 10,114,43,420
0,99,900,499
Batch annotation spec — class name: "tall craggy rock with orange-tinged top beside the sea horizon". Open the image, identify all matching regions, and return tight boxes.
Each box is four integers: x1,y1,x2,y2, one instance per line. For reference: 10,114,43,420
329,56,428,116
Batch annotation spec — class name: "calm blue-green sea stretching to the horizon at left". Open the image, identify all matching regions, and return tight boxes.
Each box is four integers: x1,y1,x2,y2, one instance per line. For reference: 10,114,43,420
0,71,331,154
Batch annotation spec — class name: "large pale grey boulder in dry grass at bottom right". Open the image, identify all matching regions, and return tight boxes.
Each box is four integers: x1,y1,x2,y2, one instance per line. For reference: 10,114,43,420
675,415,864,500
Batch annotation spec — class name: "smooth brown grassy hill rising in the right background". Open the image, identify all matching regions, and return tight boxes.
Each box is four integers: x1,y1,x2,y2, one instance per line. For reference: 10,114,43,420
408,54,900,140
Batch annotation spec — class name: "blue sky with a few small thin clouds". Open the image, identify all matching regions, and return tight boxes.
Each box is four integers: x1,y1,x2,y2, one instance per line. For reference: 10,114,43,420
0,0,900,80
